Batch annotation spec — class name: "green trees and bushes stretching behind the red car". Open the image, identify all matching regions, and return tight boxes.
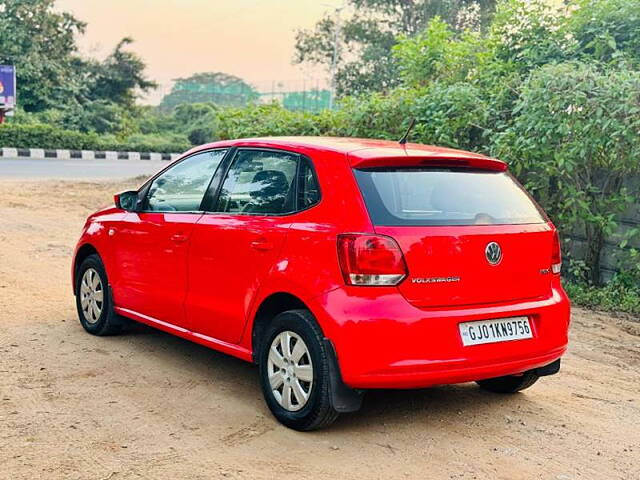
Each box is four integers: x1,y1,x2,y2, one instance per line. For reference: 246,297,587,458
0,0,640,293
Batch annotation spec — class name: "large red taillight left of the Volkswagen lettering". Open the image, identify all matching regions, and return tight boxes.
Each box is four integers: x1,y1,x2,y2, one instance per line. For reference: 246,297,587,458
338,233,407,286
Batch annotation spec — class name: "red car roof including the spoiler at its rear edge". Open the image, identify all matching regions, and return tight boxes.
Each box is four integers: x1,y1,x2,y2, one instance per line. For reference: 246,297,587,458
190,137,507,171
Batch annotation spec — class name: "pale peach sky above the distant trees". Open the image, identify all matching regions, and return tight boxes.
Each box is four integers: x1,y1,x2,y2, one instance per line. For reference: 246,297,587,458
56,0,341,104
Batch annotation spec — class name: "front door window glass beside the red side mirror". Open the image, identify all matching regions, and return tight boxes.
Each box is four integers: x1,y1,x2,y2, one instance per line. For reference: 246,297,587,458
145,150,226,212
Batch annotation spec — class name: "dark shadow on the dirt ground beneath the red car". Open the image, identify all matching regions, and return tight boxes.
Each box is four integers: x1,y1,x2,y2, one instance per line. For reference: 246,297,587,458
115,322,536,432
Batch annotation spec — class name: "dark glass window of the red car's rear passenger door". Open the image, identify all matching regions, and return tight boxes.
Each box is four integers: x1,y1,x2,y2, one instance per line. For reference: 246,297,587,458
216,150,299,215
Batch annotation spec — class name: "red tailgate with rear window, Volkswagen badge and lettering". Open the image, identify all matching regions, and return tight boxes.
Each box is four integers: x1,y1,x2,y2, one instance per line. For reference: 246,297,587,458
355,168,554,307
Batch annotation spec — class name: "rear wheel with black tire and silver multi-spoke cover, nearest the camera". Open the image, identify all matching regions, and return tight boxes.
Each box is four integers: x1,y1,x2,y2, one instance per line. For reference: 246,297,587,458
258,310,339,431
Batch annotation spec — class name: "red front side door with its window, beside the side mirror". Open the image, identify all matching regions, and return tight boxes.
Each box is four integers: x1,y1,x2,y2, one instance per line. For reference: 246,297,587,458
109,150,225,328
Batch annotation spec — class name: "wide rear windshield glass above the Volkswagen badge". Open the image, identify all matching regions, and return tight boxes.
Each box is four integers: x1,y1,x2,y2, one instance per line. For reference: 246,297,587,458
355,168,545,226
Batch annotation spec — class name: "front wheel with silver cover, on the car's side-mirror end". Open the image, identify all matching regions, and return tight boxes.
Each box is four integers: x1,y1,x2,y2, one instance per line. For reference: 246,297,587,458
76,254,123,336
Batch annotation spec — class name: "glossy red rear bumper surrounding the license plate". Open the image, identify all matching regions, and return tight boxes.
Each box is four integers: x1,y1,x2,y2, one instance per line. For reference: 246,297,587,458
314,282,570,388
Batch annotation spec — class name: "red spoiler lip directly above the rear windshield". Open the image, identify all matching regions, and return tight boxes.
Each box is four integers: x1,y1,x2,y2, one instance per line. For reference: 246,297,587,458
349,149,507,172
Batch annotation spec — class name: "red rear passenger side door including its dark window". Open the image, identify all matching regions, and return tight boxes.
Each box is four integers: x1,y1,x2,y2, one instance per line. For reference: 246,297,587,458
187,148,300,343
